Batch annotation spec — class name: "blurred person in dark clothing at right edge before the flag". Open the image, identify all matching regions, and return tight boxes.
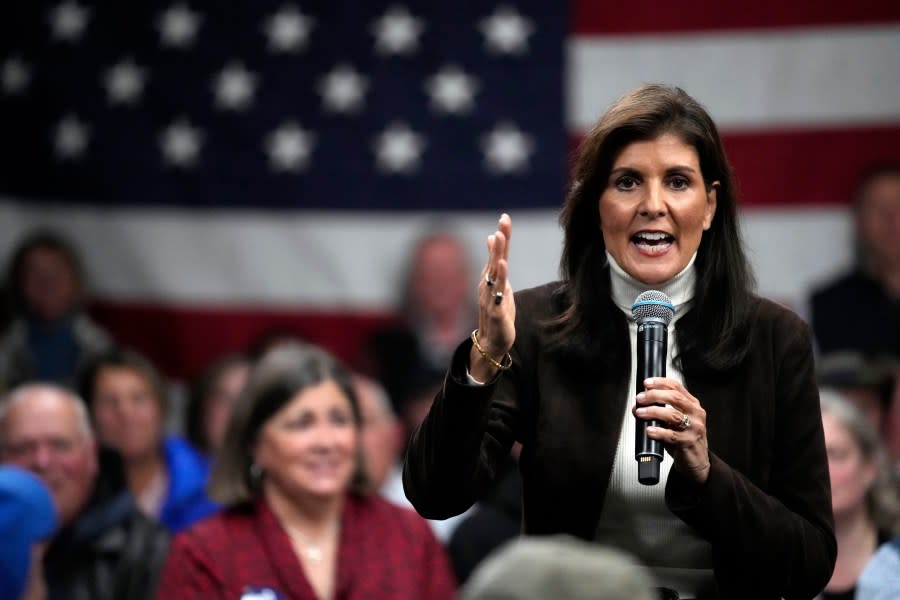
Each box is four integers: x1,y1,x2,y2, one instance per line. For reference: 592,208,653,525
811,164,900,357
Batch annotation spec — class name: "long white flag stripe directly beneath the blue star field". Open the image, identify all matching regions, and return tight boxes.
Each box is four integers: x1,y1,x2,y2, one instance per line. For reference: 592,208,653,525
0,200,852,311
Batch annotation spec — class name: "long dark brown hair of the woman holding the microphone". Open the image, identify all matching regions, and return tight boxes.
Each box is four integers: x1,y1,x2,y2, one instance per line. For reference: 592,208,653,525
551,84,754,370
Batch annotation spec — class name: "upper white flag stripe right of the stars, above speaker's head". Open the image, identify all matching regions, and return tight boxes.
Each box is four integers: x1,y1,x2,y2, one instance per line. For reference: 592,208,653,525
567,25,900,132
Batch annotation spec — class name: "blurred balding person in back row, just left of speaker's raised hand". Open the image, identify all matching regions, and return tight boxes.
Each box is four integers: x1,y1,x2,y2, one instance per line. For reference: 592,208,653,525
362,231,476,412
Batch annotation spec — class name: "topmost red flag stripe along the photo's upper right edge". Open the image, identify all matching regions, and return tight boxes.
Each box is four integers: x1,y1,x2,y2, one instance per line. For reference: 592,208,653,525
571,0,900,35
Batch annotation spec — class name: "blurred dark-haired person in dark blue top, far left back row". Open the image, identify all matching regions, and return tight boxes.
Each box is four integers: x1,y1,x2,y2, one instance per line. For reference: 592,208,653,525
0,231,112,389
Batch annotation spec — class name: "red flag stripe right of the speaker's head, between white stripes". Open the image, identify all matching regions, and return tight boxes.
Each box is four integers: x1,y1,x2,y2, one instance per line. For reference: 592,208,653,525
573,124,900,208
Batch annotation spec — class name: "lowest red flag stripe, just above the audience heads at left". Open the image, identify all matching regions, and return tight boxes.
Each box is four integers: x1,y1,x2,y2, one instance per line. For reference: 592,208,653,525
91,301,391,379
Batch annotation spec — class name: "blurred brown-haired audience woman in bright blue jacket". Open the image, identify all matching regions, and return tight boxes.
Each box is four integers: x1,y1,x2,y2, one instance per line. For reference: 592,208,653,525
81,348,218,532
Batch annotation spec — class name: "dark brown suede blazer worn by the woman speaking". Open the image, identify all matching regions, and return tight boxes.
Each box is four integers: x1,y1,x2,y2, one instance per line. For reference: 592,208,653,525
404,283,837,600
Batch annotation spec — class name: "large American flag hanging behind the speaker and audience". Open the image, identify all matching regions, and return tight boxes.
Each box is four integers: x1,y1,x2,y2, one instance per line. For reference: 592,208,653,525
0,0,900,377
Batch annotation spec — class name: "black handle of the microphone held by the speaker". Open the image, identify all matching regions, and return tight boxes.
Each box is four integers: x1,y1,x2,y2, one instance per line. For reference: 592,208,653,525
634,319,668,485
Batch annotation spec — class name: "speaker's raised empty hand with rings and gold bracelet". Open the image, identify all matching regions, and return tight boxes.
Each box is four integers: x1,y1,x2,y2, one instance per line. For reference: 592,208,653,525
469,213,516,382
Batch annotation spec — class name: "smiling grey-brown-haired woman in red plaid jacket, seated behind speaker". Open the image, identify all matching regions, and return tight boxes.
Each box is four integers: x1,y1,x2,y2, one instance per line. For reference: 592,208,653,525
158,345,455,600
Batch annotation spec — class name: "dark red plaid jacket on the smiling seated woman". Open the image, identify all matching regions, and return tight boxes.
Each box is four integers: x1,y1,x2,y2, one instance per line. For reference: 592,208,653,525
157,495,456,600
